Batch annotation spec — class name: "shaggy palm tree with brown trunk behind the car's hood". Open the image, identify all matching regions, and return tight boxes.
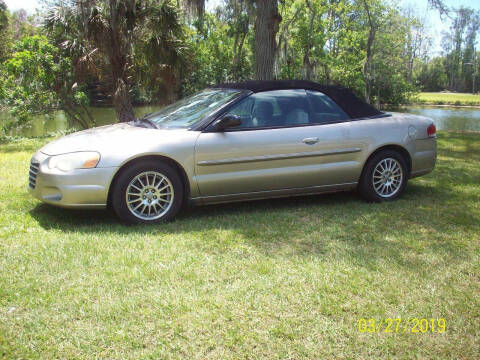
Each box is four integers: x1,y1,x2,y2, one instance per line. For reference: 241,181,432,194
45,0,186,122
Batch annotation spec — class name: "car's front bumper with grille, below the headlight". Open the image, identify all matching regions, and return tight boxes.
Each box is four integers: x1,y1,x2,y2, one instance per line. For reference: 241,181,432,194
28,152,118,209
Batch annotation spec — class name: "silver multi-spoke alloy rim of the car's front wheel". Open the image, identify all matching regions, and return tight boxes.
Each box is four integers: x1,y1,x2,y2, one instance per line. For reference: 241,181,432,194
125,171,174,220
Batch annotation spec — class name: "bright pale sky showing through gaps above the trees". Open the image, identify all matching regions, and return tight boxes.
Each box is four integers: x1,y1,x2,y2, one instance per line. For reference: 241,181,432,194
4,0,480,56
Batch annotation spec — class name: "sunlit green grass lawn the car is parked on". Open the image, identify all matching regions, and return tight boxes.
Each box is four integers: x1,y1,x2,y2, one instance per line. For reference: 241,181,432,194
0,132,480,359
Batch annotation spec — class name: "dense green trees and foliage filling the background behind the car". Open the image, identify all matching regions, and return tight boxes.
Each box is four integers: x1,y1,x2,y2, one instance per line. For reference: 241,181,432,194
0,0,480,127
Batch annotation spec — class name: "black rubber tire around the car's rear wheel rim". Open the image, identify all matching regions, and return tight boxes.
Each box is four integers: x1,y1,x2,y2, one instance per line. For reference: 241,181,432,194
358,150,409,202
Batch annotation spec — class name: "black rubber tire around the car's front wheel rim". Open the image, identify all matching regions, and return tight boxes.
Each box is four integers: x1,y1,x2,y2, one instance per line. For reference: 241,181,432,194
112,160,185,224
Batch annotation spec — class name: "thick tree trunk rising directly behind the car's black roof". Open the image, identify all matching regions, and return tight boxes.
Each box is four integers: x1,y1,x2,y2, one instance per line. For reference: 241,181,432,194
254,0,282,80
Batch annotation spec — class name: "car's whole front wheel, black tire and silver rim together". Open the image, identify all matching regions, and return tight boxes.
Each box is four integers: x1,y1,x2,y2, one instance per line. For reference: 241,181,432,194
112,161,184,223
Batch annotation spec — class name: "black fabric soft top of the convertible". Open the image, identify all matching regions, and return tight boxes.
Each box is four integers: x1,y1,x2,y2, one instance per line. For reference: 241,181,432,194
212,80,383,118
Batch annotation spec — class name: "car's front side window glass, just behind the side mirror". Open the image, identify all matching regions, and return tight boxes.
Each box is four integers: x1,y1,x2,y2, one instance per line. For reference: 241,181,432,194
227,90,312,128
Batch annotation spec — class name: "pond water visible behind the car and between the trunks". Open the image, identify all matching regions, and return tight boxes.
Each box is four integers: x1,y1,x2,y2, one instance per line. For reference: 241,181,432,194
0,105,480,137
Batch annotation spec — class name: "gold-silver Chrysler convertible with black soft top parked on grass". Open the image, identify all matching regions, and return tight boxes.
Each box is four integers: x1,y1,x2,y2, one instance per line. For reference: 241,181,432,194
29,80,436,223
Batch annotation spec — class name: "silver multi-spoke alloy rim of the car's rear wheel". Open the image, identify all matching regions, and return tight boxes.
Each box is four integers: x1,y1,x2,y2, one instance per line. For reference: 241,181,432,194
372,158,403,198
